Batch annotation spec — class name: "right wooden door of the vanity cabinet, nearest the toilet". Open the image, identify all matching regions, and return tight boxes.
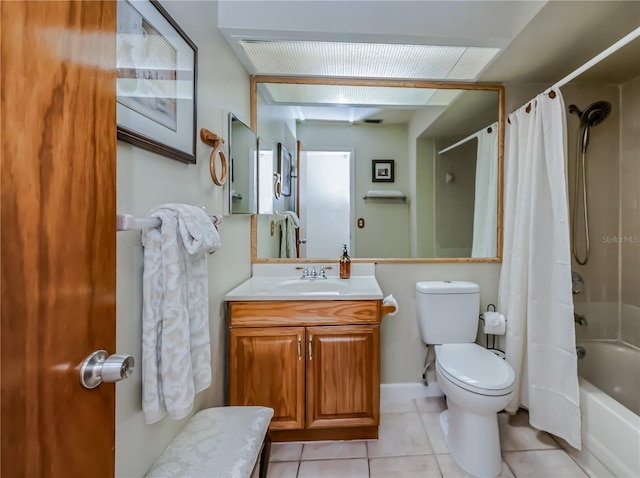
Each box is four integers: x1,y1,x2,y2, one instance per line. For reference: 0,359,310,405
306,325,380,428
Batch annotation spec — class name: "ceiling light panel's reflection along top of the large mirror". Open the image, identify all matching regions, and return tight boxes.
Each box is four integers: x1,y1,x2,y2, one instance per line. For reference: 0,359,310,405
263,83,437,106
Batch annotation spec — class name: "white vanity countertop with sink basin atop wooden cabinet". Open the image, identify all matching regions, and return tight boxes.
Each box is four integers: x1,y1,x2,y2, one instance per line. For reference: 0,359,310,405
225,276,382,300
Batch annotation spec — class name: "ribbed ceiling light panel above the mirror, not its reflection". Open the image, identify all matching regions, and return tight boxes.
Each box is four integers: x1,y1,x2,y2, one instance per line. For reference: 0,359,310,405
240,40,498,80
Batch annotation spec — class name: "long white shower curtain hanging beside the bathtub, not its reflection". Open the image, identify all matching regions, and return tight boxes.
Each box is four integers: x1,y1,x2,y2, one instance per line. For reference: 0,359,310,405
498,92,581,449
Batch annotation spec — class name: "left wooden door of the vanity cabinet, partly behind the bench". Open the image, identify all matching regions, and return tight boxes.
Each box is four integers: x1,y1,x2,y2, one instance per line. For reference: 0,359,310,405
229,327,304,430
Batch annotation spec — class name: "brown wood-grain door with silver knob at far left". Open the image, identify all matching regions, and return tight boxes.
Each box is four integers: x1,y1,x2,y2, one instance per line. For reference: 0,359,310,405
0,0,116,478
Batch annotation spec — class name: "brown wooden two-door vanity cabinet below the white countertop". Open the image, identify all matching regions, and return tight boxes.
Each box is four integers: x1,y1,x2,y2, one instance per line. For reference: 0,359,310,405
229,300,381,441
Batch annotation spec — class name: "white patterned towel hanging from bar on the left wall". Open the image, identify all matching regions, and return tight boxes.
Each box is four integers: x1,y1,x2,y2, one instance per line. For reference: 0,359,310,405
142,204,220,423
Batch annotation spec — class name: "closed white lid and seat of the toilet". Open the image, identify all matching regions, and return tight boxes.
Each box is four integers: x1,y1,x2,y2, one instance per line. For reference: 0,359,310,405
436,343,515,396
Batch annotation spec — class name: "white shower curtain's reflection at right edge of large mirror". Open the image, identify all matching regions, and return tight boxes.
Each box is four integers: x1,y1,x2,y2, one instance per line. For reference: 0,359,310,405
471,123,498,257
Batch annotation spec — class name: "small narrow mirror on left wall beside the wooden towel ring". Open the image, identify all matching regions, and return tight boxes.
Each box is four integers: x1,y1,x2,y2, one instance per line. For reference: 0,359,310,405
229,113,258,214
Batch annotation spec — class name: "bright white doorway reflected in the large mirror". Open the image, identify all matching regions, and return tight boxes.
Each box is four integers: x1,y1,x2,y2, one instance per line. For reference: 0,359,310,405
299,151,354,258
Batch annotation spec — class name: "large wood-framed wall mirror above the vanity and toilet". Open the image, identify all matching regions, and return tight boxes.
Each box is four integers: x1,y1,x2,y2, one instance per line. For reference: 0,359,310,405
251,77,504,263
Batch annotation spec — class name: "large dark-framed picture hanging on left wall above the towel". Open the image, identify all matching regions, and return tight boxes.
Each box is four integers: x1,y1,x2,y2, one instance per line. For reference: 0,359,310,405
116,0,198,163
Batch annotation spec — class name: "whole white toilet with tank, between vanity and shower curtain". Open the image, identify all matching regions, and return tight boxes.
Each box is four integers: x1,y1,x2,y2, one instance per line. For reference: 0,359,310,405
416,281,515,478
